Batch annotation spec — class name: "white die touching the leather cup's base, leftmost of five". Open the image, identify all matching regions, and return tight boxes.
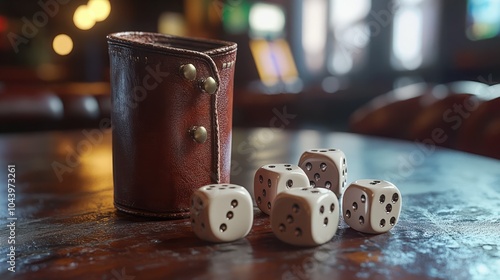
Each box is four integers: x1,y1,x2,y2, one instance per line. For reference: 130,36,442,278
190,184,253,242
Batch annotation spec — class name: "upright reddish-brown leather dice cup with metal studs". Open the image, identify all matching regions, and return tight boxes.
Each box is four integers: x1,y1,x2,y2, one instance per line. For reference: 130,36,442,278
107,32,237,218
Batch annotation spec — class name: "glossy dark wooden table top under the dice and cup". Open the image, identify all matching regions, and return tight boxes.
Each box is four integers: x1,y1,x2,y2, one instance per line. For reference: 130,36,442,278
0,128,500,280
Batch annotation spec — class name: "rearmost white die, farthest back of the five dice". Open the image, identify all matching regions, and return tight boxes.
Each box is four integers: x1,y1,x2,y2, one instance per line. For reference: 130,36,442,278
299,149,347,198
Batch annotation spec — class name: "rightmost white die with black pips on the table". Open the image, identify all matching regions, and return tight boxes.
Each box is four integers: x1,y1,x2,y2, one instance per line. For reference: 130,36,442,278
342,179,403,234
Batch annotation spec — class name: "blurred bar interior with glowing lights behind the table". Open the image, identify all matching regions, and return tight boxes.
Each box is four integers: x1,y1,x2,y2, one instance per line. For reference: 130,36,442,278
0,0,500,157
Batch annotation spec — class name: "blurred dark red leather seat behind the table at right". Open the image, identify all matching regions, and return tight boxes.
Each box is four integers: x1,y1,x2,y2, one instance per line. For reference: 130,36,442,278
350,81,500,159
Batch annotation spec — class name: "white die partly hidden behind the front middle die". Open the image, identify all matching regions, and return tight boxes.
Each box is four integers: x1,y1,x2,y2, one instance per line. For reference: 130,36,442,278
253,163,309,215
